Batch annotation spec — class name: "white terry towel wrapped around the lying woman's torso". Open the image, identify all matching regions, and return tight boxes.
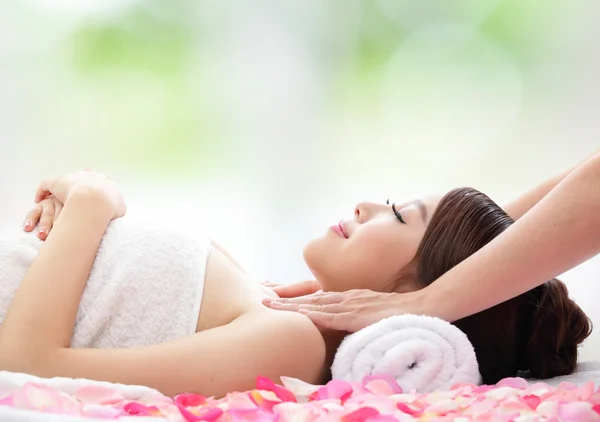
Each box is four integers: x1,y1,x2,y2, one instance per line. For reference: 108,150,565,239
0,217,210,348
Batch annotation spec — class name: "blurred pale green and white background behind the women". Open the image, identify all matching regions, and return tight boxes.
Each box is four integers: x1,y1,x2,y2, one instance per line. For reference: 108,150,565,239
0,0,600,357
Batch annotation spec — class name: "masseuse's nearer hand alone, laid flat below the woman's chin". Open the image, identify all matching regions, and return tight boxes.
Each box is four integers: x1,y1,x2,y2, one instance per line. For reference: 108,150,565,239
263,286,422,333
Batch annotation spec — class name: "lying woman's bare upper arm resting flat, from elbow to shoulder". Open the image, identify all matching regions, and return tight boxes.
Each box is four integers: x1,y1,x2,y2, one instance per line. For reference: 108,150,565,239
9,311,325,397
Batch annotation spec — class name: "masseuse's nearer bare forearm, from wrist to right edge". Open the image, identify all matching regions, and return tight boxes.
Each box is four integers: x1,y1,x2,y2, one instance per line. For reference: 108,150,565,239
418,153,600,321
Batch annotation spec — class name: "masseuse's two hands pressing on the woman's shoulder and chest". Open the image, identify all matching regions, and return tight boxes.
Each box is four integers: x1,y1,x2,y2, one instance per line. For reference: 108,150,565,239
263,280,413,333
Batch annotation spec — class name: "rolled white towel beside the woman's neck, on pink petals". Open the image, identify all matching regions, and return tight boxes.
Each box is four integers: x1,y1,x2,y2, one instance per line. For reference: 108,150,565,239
331,315,481,393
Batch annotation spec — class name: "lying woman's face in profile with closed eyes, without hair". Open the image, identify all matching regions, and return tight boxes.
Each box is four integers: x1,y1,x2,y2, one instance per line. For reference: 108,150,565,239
304,197,440,291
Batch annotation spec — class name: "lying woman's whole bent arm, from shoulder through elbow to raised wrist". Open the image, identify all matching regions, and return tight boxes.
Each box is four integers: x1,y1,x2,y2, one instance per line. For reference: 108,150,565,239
0,176,325,396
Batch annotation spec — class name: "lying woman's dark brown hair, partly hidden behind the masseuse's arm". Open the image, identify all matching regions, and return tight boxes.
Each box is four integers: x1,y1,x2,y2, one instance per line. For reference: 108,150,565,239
400,188,592,384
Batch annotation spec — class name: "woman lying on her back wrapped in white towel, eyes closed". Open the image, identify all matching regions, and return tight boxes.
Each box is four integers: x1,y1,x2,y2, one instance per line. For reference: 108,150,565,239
0,172,591,396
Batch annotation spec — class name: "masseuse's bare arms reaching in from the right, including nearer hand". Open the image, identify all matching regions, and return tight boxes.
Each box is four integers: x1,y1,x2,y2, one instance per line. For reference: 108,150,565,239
264,152,600,331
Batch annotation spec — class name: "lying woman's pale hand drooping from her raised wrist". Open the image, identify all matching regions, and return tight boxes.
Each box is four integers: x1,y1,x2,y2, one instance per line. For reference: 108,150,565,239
35,170,126,220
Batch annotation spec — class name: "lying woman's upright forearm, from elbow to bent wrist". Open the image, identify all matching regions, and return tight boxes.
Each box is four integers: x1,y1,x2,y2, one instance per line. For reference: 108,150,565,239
0,193,113,360
